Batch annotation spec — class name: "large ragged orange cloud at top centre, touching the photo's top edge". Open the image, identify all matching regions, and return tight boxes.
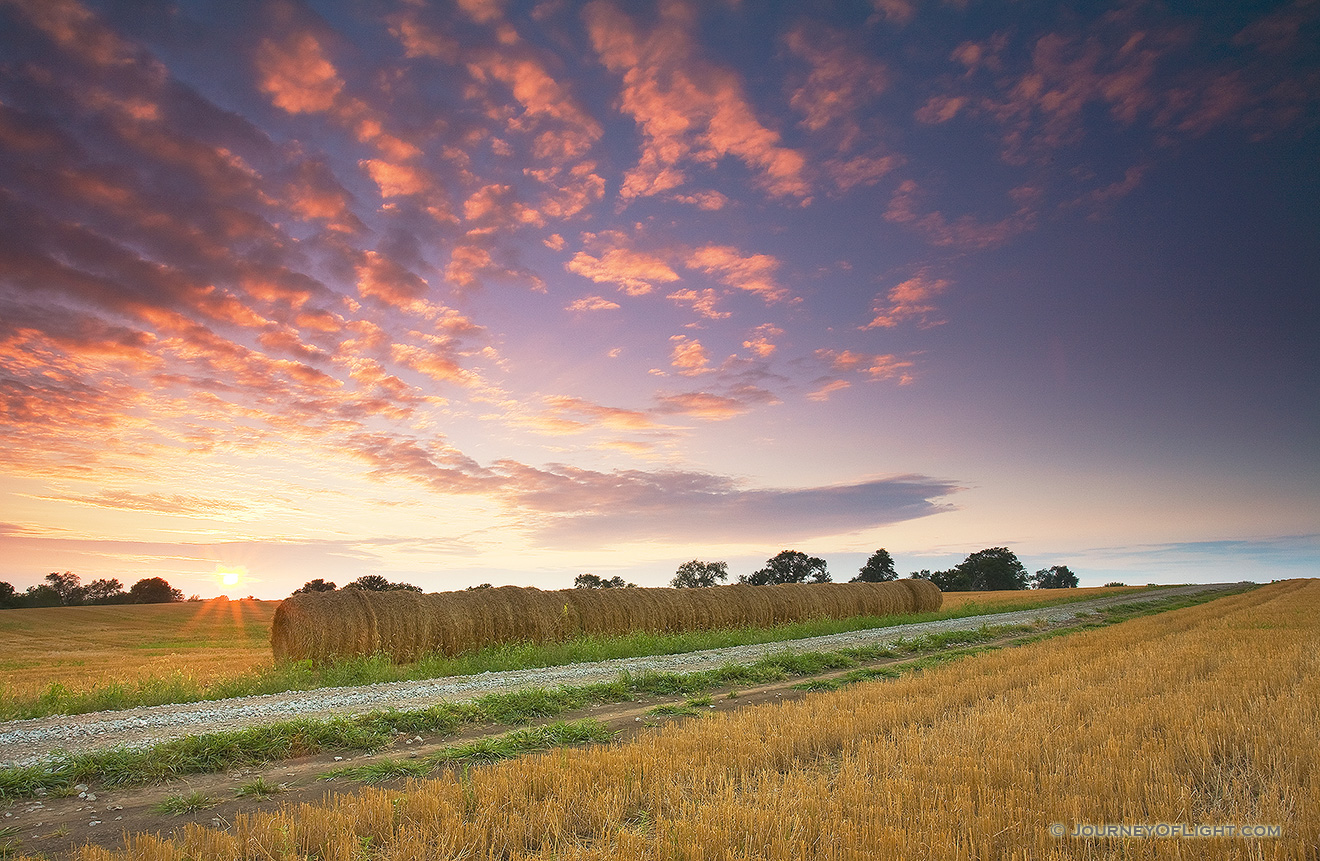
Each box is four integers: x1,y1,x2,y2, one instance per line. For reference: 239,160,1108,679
583,0,809,199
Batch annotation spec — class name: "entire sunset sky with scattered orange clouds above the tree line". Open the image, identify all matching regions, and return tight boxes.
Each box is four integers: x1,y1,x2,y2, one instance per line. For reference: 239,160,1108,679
0,0,1320,598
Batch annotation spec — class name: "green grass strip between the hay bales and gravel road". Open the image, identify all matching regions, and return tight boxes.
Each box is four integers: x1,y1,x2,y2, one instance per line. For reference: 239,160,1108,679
0,586,1177,720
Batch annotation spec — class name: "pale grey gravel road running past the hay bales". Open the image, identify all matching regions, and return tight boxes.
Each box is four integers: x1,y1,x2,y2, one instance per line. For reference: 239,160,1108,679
0,584,1238,766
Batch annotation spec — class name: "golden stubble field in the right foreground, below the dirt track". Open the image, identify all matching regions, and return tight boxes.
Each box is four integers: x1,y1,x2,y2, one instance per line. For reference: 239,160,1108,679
12,580,1320,861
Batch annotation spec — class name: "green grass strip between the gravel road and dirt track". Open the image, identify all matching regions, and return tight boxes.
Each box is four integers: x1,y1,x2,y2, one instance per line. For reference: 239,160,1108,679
0,589,1241,799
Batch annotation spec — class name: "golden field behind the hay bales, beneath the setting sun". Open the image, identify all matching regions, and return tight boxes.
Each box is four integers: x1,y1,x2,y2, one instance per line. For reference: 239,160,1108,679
0,588,1145,717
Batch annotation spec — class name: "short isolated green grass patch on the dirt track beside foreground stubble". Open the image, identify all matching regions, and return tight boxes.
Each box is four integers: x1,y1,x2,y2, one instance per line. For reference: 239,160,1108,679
321,718,614,783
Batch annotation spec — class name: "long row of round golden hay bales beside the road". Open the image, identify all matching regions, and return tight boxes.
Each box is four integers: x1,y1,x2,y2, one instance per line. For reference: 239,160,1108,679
271,580,944,663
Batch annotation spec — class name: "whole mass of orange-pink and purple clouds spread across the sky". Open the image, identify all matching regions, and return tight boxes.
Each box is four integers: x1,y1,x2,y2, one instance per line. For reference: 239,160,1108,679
0,0,1320,549
